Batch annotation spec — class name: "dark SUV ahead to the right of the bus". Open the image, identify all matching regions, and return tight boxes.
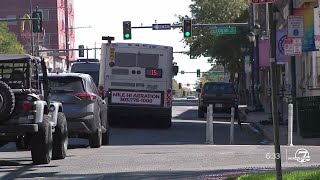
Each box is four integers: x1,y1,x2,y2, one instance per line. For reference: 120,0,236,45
197,82,239,118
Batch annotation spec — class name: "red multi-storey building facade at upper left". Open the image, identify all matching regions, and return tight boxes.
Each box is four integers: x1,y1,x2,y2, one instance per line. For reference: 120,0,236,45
0,0,75,69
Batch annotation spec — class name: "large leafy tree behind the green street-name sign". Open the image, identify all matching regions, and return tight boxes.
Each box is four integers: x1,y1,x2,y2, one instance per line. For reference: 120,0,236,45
175,0,249,80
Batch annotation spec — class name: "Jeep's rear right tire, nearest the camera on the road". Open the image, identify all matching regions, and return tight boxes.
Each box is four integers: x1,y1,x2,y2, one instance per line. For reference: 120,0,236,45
31,115,52,165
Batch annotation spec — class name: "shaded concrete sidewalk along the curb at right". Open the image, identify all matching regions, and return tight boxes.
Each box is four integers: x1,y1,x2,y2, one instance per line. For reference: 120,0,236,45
239,106,320,146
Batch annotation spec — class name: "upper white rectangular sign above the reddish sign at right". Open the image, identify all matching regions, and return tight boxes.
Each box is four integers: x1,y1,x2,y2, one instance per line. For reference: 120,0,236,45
288,16,304,38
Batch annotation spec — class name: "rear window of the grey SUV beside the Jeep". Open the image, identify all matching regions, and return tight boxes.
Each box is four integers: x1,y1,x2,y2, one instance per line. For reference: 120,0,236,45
49,77,85,93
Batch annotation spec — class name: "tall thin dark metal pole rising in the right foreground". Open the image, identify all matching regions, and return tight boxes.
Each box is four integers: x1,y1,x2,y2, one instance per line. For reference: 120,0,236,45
267,3,282,180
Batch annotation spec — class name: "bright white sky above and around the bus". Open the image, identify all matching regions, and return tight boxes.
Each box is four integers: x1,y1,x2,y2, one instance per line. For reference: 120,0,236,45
74,0,211,88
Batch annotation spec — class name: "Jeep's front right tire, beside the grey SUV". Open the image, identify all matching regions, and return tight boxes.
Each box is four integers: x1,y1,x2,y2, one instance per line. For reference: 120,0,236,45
52,112,68,160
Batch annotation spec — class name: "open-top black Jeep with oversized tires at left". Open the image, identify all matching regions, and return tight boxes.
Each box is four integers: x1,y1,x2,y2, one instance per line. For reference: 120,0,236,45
0,54,68,164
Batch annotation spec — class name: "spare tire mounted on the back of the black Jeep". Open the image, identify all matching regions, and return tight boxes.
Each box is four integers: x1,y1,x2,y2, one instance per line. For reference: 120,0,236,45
0,81,15,122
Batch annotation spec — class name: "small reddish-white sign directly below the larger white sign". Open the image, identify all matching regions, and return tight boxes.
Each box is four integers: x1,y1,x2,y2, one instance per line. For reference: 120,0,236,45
284,38,302,56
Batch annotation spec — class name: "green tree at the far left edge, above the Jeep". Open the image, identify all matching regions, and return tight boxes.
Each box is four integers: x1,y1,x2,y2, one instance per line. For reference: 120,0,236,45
0,23,24,54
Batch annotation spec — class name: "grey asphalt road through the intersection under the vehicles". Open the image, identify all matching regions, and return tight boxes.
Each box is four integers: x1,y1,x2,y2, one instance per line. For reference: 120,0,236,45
0,101,320,179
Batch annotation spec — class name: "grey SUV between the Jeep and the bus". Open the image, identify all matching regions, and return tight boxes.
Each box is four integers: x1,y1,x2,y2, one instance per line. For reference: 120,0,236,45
48,73,109,148
